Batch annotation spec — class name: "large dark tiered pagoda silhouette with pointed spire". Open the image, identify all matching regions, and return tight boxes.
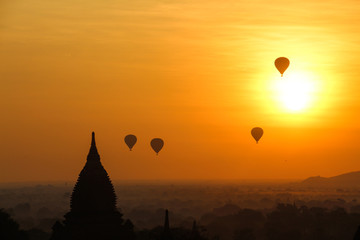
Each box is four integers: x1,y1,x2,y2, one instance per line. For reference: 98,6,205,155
50,132,135,240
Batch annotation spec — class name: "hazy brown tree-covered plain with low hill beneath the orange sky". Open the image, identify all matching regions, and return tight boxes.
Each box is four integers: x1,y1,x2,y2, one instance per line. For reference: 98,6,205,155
0,172,360,240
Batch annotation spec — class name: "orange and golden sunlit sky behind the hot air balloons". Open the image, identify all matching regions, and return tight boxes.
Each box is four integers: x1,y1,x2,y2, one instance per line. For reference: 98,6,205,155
0,0,360,182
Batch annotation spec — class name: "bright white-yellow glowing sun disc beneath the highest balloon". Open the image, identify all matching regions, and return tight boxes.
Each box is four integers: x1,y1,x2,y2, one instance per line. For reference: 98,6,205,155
275,73,315,112
